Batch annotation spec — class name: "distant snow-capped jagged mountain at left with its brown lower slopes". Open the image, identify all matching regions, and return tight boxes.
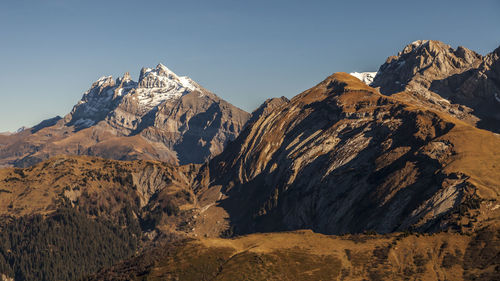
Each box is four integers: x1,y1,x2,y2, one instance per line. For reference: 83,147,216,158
0,64,250,167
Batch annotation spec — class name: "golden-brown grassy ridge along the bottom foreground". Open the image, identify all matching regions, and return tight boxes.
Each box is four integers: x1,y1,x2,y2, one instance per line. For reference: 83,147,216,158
92,230,500,280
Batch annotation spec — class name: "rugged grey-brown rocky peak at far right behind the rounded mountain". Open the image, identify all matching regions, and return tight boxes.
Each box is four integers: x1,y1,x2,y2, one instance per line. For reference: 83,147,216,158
371,40,500,132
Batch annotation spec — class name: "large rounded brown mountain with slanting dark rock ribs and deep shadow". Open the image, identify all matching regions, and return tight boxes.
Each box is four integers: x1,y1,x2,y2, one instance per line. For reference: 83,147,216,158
195,73,500,235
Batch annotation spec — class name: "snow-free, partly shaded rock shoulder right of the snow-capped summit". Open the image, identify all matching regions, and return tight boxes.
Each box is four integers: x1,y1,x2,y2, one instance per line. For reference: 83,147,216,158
141,91,249,164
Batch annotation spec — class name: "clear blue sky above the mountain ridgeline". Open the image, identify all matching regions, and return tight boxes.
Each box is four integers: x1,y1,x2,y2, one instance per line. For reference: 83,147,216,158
0,0,500,132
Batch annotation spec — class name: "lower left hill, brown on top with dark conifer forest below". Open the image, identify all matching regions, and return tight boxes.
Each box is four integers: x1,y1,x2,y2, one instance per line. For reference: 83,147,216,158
0,156,197,280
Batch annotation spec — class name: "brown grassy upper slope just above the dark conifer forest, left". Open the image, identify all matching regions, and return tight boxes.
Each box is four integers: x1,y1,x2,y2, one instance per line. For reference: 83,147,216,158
0,156,198,230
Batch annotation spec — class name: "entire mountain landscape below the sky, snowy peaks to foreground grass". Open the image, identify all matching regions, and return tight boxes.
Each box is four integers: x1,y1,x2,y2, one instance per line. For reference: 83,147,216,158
0,40,500,280
